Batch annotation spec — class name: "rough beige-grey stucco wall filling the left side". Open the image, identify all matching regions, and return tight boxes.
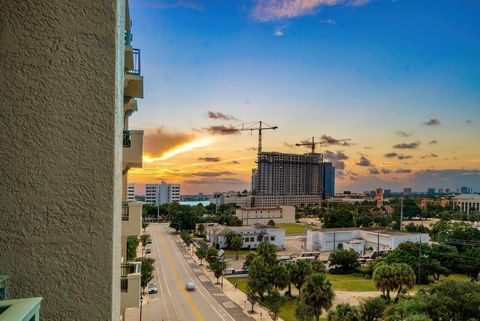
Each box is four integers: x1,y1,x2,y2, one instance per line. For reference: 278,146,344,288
0,0,124,321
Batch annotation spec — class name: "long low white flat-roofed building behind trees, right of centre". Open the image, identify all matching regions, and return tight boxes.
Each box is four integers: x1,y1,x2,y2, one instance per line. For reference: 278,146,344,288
306,228,430,254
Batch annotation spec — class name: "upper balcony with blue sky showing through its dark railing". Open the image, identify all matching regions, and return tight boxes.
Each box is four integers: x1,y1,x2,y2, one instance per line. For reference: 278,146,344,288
124,46,143,98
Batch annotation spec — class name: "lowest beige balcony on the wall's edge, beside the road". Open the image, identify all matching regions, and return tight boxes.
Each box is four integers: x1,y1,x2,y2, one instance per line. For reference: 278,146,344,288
120,262,142,311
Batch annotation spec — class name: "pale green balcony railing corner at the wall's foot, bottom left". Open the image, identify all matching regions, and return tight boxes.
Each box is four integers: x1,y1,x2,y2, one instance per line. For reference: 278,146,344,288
0,298,43,321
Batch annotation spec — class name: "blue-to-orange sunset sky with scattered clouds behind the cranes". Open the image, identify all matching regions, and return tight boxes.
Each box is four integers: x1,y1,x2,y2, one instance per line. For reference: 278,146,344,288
129,0,480,194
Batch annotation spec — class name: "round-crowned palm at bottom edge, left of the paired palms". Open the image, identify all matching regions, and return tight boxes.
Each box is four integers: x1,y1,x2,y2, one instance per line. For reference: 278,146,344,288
298,272,335,321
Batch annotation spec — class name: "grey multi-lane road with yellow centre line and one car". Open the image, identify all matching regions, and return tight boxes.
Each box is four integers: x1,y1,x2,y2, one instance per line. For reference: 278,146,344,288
142,224,253,321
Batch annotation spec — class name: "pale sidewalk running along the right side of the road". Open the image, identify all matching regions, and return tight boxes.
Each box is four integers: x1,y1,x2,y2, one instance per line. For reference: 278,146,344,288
183,242,283,321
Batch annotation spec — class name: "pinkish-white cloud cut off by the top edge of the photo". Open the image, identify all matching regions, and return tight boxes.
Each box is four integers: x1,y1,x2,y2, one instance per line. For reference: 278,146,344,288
251,0,371,21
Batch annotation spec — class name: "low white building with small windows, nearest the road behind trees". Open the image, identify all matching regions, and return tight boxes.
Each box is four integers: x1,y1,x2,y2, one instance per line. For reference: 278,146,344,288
205,224,285,250
